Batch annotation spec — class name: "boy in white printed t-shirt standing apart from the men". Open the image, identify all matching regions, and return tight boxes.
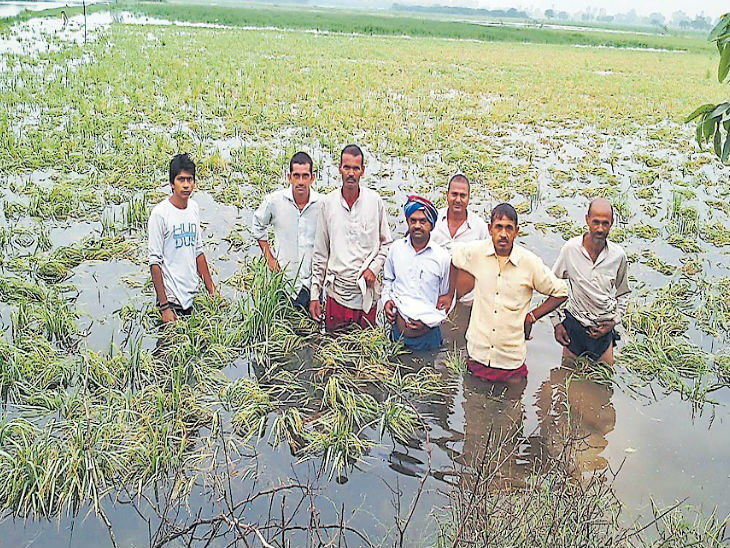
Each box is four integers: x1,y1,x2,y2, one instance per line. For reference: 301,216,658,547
148,154,215,323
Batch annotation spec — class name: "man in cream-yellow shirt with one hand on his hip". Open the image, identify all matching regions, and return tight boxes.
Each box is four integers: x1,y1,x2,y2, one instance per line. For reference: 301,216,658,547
439,204,568,382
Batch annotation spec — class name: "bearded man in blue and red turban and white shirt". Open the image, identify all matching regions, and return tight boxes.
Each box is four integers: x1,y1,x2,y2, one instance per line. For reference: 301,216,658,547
383,196,451,350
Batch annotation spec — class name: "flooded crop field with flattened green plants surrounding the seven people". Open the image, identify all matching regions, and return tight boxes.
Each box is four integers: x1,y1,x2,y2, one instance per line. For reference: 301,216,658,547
0,8,730,547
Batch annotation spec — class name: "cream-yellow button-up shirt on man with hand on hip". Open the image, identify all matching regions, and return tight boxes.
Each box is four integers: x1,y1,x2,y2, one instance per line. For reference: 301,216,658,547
452,239,568,369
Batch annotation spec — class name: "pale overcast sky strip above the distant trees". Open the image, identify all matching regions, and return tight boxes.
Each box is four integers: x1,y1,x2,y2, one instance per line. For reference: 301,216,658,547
474,0,730,18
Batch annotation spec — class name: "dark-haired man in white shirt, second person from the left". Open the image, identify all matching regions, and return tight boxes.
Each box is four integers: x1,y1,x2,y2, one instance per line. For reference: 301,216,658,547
251,152,320,310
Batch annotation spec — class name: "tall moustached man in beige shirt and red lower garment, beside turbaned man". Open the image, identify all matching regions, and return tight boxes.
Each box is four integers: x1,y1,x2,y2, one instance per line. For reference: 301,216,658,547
309,145,393,331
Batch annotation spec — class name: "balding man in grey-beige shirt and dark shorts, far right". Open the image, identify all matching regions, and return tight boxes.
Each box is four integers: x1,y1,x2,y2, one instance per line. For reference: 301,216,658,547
551,198,630,365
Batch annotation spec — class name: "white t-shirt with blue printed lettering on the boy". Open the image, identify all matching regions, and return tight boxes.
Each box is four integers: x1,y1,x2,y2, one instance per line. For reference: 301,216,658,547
148,199,203,308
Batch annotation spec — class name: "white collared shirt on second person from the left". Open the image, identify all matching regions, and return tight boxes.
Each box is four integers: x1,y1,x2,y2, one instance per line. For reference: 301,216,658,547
251,187,321,293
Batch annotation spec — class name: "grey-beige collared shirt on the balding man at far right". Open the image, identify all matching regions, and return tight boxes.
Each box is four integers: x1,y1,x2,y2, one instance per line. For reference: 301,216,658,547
550,236,631,327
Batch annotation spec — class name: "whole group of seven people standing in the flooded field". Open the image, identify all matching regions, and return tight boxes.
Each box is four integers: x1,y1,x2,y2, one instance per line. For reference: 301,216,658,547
149,145,629,382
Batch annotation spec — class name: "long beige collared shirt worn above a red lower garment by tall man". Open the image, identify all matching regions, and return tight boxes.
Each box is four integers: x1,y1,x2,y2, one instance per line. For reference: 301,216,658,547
311,185,393,312
